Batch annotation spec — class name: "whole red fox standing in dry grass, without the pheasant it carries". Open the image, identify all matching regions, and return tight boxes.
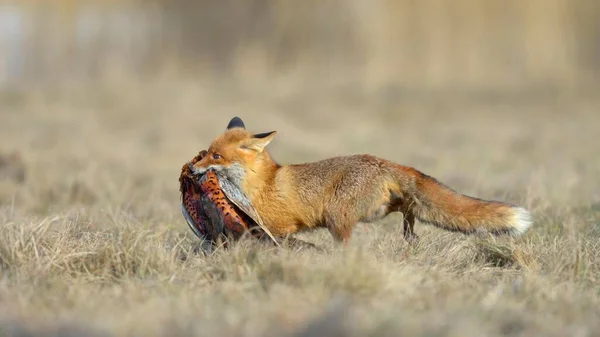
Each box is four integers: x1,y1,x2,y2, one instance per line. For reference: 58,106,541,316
192,117,532,244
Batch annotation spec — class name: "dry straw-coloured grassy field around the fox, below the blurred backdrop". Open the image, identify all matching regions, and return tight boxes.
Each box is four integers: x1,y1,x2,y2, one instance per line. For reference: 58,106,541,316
0,82,600,337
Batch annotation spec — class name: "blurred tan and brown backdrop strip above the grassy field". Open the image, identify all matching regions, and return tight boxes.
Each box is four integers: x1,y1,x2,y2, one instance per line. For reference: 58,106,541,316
0,0,600,92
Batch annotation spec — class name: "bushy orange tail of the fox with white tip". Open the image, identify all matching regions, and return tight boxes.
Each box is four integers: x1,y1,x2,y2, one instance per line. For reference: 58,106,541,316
411,172,532,235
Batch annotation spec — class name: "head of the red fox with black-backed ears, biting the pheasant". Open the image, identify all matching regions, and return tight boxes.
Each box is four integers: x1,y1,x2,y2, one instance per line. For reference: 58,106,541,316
192,117,277,187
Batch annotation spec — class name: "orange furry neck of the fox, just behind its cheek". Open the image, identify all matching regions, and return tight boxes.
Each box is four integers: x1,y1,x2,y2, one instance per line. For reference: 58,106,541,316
241,150,281,200
